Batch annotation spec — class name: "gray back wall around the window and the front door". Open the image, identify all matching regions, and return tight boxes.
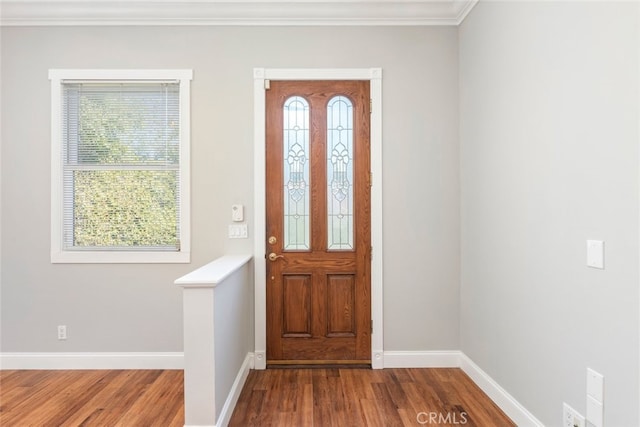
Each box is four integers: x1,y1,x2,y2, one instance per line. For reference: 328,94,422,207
0,27,460,352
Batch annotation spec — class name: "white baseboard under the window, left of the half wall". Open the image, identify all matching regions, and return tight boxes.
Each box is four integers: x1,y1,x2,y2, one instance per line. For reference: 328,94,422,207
0,352,184,370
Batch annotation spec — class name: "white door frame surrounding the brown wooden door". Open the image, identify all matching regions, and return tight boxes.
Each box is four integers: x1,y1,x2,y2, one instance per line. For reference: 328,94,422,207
253,68,384,369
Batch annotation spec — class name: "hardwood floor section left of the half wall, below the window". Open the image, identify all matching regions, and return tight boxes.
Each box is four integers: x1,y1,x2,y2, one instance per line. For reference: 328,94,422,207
0,370,184,427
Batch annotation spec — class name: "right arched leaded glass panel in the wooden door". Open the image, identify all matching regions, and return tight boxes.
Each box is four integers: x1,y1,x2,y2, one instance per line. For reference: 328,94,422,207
327,96,354,250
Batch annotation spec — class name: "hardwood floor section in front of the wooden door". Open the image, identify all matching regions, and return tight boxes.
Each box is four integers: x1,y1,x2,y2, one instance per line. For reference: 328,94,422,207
229,369,515,427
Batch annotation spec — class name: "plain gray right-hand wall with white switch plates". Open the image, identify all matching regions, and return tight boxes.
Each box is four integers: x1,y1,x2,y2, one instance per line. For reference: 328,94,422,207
459,1,640,426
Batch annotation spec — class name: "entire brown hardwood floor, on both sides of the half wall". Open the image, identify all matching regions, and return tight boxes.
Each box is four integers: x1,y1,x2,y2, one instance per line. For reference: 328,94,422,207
0,368,515,427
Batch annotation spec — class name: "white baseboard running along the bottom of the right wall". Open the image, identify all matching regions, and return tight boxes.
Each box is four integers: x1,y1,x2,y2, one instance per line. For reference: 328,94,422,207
460,353,544,427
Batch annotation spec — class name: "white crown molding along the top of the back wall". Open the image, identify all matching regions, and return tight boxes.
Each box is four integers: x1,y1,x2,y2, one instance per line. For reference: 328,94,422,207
0,0,478,26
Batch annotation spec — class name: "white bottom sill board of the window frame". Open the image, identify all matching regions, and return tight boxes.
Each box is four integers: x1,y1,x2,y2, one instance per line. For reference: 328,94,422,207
51,251,191,264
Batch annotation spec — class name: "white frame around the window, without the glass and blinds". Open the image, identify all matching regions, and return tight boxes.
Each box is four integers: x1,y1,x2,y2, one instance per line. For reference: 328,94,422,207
49,69,193,264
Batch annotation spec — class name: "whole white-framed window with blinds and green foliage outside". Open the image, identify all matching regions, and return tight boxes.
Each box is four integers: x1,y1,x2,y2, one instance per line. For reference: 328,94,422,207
49,70,192,263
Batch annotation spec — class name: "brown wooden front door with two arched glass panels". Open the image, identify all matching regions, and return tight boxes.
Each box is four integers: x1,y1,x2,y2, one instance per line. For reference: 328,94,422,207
265,81,371,365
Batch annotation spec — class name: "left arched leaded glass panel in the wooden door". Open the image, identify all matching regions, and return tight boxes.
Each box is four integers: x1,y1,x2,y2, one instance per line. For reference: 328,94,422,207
283,96,311,250
